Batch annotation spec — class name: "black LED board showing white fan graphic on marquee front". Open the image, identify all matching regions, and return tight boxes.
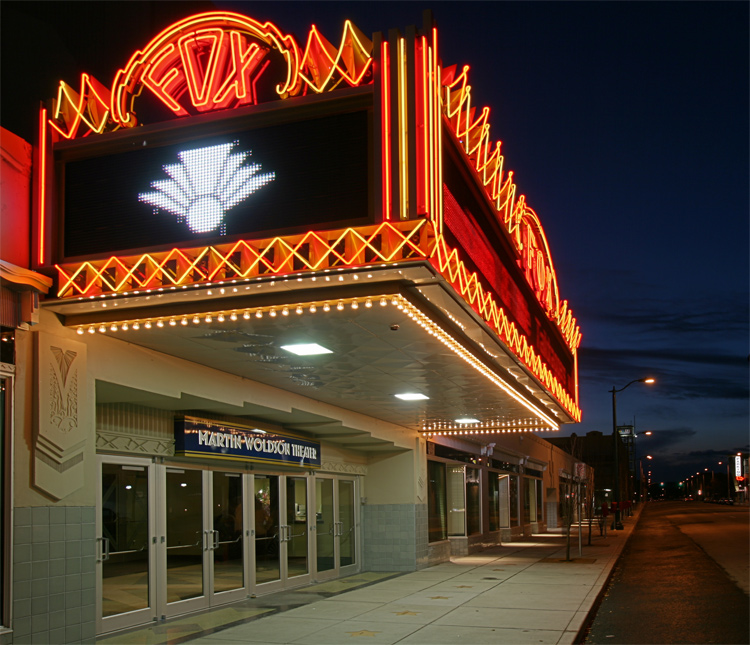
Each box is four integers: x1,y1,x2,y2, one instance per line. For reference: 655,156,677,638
59,110,372,258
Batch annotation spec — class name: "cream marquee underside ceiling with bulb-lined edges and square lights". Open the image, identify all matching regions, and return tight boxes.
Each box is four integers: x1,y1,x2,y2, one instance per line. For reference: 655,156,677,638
45,263,571,452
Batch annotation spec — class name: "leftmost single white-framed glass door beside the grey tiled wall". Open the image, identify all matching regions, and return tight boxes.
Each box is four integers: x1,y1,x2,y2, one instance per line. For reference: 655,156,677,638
96,458,157,632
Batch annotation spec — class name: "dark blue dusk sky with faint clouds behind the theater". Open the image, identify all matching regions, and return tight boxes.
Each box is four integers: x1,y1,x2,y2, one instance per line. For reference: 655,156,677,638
0,1,750,480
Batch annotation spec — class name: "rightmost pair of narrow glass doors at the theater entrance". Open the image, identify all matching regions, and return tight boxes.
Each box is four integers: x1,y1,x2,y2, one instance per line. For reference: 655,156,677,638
315,476,358,580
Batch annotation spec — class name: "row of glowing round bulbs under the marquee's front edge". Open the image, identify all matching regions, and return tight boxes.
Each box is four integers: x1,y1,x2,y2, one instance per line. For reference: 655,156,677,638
76,296,396,334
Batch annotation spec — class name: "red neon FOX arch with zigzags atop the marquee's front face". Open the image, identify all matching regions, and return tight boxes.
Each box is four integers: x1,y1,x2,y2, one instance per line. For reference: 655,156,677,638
49,12,373,139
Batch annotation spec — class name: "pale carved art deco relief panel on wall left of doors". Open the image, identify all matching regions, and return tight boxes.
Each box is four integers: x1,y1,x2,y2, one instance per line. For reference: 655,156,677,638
33,333,90,499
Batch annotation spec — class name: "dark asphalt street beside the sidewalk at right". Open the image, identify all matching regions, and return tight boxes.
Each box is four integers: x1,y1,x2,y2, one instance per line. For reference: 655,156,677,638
584,502,750,645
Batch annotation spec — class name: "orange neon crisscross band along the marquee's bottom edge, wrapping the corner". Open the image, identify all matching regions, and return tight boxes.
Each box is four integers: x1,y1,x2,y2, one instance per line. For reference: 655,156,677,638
55,219,581,420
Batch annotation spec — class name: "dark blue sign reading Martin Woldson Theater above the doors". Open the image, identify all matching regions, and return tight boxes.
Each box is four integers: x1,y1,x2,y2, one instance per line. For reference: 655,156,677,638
175,417,320,468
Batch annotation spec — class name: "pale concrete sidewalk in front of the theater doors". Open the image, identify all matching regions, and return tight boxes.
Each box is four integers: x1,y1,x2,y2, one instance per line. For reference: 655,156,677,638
97,515,637,645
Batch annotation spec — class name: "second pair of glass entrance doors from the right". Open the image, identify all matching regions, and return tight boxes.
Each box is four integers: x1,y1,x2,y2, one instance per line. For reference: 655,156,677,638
253,475,310,593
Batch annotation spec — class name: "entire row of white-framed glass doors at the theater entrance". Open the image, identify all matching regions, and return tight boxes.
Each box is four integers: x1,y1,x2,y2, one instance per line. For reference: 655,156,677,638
96,455,358,633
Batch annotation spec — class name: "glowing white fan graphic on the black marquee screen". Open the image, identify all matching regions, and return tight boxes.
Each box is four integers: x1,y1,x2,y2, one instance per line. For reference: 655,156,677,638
138,142,276,235
